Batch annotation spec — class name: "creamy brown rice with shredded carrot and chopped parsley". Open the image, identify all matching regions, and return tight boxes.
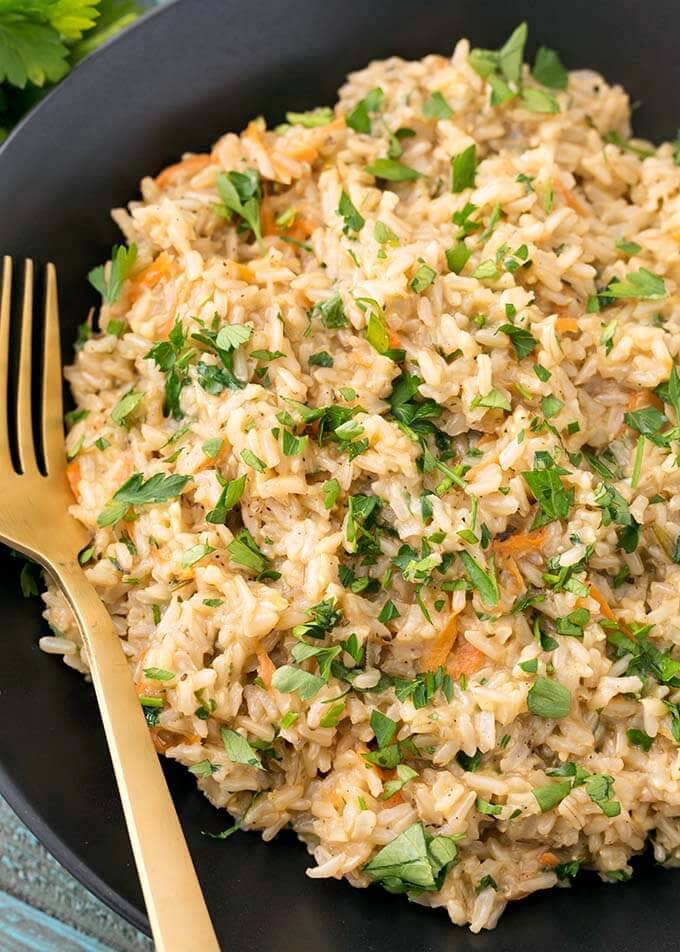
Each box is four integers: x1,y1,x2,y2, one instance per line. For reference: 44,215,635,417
43,25,680,931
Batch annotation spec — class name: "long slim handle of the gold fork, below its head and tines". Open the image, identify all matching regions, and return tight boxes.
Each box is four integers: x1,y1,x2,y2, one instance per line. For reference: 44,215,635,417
51,562,219,952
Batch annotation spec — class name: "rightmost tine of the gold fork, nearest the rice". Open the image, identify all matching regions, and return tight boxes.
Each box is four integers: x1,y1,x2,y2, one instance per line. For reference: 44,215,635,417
42,264,65,473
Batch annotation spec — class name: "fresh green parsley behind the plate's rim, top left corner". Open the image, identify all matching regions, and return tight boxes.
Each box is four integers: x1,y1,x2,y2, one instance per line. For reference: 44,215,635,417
0,0,148,142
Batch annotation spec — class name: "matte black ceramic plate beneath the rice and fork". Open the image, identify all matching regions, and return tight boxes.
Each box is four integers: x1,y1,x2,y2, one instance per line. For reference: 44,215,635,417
0,0,680,952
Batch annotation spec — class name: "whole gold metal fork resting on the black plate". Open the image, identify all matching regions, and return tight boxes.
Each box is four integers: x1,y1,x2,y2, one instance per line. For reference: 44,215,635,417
0,257,219,952
